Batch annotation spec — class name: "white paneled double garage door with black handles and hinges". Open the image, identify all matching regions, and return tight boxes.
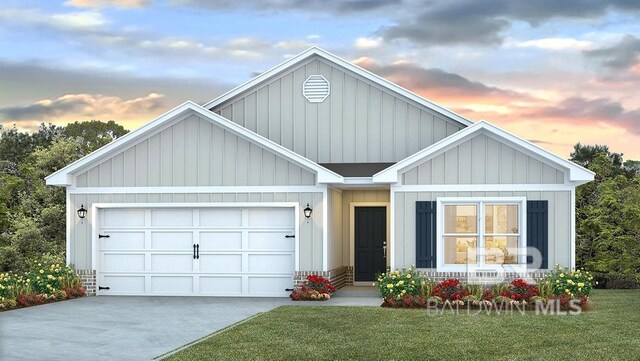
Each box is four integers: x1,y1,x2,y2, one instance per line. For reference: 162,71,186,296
97,207,295,297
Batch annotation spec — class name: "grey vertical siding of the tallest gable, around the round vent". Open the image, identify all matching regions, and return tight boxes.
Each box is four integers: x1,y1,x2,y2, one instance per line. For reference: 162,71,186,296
212,57,463,163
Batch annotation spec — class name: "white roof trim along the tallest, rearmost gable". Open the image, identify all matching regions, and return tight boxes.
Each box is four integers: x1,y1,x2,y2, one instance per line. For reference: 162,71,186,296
203,46,473,127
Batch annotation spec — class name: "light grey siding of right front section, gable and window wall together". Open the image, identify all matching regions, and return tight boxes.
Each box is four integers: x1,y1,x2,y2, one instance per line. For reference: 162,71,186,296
391,134,574,268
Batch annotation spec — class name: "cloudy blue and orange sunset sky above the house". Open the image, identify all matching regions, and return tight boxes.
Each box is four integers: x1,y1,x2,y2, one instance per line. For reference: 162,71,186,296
0,0,640,159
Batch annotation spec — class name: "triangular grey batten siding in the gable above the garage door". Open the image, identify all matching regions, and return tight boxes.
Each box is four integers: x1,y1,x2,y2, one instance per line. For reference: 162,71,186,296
77,115,315,187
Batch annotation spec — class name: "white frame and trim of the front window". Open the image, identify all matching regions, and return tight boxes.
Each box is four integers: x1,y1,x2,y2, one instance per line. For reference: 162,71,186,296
436,197,527,272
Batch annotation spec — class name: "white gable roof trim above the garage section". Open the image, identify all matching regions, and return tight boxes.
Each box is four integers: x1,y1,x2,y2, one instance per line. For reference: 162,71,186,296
45,101,344,186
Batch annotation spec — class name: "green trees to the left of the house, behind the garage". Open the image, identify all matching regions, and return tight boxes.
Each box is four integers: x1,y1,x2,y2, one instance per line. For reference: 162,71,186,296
0,120,127,272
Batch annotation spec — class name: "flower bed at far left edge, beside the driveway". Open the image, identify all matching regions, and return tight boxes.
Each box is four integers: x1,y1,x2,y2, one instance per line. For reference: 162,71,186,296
0,261,85,312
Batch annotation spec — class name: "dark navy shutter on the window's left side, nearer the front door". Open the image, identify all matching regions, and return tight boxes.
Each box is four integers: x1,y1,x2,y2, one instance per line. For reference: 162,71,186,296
416,201,437,268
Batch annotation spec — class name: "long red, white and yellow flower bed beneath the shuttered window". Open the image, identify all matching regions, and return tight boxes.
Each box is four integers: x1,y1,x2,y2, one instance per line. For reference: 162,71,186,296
378,266,593,311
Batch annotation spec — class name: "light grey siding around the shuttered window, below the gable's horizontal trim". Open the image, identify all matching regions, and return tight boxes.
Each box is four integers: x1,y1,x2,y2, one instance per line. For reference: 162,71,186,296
393,191,572,268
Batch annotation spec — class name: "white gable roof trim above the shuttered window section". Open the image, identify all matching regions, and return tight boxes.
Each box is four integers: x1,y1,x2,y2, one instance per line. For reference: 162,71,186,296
373,120,595,185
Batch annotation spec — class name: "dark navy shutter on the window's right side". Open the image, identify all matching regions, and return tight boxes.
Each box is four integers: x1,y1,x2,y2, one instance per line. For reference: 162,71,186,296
527,201,549,269
